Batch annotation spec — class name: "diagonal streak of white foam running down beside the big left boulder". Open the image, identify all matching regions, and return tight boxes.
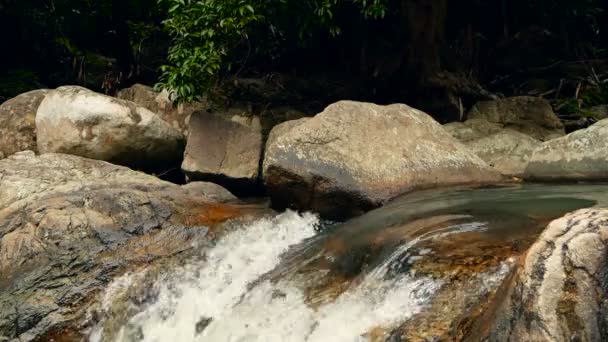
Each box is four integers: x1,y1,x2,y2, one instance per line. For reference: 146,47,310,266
111,212,318,342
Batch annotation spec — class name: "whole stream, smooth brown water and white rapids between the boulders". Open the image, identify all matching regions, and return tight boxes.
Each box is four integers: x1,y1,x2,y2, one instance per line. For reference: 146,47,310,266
89,185,608,342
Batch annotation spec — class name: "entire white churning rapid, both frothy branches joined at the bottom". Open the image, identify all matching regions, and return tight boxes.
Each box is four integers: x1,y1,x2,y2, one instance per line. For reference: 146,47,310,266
90,212,440,342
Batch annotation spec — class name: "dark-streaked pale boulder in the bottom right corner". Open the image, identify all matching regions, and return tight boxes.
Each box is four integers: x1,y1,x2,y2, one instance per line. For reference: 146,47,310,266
489,209,608,341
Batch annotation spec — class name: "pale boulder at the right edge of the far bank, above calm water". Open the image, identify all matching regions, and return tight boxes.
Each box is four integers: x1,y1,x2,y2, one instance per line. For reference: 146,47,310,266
525,119,608,181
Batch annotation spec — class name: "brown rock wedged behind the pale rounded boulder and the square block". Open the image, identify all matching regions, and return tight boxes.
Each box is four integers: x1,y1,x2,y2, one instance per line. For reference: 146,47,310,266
116,84,204,136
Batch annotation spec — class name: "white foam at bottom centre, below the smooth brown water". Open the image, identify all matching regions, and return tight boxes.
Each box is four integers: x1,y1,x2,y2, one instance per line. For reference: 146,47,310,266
200,277,439,342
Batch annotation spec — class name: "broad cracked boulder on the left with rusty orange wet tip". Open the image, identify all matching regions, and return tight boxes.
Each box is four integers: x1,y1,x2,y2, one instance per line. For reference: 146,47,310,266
0,152,252,341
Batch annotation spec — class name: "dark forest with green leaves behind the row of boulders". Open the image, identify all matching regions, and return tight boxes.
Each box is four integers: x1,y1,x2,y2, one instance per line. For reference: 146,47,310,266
0,0,608,121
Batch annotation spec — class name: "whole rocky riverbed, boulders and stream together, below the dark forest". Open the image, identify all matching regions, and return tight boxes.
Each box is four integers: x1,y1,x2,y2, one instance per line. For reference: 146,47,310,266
0,86,608,342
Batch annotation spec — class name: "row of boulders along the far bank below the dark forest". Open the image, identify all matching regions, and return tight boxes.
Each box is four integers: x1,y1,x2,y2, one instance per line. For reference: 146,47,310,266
0,85,608,218
